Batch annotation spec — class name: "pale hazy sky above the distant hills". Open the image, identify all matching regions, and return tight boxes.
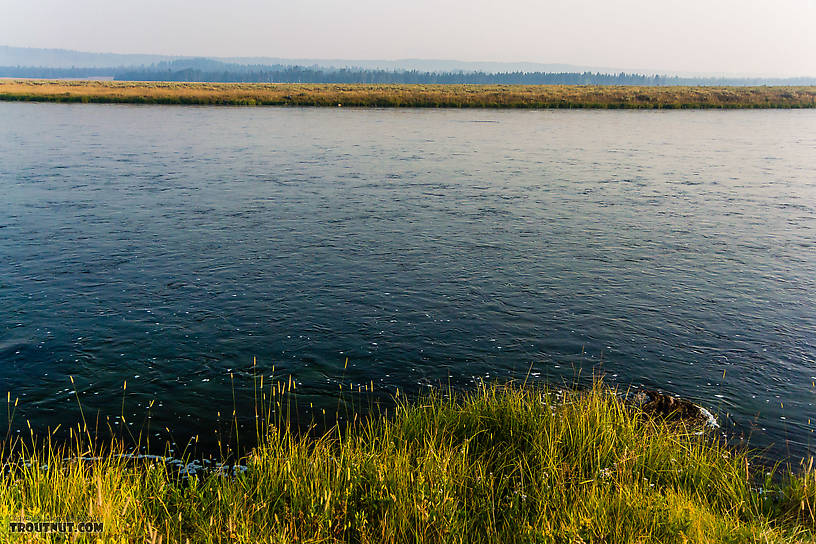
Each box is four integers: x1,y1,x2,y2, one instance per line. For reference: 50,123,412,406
0,0,816,76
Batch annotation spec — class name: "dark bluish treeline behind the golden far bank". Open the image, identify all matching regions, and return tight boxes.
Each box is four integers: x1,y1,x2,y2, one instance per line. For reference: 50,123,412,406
0,59,816,87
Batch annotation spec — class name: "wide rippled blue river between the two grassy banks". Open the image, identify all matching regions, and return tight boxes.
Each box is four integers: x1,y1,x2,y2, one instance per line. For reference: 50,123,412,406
0,103,816,458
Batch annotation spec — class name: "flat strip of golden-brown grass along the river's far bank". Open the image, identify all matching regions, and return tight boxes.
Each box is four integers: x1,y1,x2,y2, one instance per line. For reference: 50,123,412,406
0,80,816,109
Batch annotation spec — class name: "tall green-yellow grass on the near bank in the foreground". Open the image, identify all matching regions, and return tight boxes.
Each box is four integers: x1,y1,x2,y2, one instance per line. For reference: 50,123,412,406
0,386,816,543
